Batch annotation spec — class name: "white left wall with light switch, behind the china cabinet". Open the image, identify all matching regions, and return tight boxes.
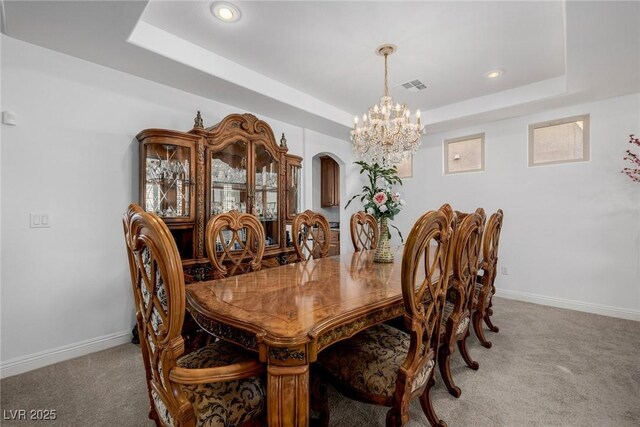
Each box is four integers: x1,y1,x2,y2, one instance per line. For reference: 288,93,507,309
1,35,330,376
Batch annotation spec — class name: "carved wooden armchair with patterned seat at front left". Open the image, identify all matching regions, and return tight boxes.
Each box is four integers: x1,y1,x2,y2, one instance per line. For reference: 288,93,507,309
123,204,266,426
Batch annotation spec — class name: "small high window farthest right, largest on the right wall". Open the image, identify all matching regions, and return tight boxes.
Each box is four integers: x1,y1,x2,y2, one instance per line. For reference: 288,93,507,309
529,114,589,166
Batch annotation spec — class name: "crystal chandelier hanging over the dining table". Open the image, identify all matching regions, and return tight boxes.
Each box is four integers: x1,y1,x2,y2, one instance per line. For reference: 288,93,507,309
351,44,422,166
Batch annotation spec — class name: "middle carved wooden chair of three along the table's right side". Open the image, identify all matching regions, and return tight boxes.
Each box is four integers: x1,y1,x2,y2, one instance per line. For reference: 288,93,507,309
438,208,485,397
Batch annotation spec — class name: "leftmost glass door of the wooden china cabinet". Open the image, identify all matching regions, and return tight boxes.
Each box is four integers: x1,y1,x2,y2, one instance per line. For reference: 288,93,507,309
142,144,193,219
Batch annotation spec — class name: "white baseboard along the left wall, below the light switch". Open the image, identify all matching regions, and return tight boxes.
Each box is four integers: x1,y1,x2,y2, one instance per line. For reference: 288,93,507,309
0,331,131,378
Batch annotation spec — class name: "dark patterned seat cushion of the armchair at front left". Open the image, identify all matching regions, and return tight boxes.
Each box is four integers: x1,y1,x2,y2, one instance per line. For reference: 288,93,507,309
177,341,266,427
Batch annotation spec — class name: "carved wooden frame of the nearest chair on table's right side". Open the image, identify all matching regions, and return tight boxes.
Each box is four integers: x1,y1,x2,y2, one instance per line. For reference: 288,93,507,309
313,210,455,426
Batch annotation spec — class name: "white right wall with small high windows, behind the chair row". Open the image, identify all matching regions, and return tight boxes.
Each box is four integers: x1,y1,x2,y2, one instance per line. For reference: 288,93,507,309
395,94,640,320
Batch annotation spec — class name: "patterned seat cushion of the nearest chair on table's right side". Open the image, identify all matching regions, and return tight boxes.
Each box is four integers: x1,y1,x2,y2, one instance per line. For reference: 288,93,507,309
318,324,434,397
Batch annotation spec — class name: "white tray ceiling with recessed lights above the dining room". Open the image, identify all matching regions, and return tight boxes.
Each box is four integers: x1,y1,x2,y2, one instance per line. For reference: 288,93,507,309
0,0,640,141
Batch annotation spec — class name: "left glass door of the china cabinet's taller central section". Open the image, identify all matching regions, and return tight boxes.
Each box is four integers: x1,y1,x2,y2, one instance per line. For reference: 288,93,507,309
209,142,248,216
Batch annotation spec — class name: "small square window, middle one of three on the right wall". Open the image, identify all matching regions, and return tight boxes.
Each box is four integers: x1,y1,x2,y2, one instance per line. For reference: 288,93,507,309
444,133,484,175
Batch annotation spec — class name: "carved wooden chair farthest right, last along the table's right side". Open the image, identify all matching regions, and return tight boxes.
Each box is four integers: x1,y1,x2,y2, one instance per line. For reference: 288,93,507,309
472,209,504,348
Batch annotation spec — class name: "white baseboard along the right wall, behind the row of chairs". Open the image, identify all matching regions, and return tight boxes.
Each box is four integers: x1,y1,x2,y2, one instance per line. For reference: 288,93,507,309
496,288,640,321
